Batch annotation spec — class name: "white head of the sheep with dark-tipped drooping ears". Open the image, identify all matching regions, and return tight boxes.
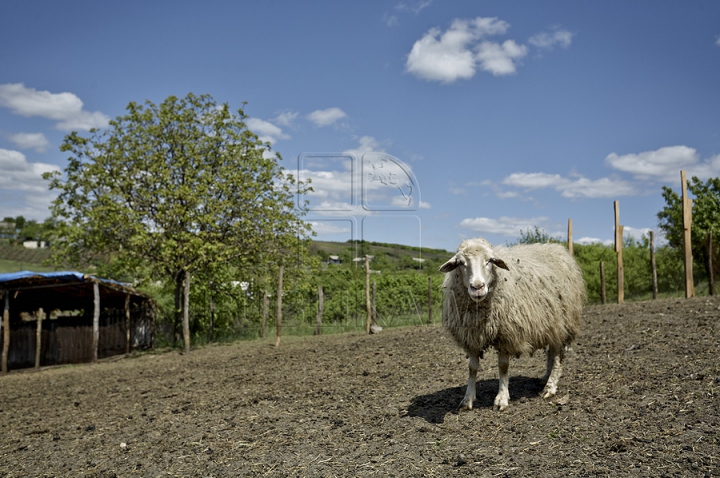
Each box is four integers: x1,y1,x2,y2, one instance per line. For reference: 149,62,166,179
440,240,508,302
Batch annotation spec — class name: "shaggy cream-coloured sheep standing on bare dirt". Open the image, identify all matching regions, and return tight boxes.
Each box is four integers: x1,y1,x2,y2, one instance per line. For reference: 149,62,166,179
440,238,586,411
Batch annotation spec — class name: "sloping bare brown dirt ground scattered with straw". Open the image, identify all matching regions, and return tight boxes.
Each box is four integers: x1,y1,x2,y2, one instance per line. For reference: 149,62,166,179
0,297,720,477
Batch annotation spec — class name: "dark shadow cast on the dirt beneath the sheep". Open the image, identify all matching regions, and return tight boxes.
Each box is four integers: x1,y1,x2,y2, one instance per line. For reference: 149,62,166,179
407,376,543,423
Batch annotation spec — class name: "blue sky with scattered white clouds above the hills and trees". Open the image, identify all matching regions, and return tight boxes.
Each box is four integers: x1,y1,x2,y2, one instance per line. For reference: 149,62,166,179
0,0,720,254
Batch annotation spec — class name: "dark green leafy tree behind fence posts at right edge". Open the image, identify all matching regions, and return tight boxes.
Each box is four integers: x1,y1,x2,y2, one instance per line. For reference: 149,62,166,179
658,176,720,280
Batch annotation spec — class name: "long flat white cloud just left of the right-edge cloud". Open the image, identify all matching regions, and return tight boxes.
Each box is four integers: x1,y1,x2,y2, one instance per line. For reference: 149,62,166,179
502,173,637,198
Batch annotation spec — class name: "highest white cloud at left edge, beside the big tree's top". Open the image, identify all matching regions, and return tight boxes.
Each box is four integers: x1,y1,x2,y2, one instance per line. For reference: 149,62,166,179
0,83,110,131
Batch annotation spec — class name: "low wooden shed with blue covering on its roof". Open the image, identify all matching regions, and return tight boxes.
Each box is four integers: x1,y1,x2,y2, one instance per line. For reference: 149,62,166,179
0,271,156,372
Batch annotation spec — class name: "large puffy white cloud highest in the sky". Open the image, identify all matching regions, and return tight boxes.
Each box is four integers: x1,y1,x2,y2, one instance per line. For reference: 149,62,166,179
405,17,527,83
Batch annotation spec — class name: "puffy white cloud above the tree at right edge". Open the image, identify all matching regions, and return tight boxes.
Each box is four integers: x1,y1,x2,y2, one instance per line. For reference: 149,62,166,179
605,146,720,181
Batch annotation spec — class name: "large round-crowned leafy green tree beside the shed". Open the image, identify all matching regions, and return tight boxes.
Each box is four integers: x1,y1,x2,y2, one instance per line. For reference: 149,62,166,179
45,93,309,351
